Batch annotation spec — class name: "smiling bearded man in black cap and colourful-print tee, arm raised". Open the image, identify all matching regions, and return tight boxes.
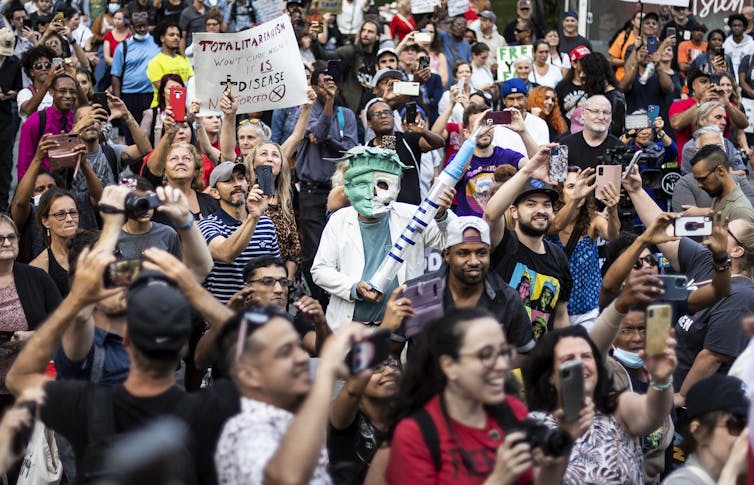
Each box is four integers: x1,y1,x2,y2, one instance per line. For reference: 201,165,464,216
484,142,568,337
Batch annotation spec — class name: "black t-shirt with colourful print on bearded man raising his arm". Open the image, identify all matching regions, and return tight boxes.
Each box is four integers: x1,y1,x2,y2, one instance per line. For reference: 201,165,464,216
490,229,573,339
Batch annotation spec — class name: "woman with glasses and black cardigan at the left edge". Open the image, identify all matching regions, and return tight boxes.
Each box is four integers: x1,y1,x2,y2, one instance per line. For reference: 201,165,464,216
0,214,60,406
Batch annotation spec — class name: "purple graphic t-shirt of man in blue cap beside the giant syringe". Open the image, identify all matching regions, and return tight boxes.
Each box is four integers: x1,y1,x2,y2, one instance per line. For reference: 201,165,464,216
455,147,524,217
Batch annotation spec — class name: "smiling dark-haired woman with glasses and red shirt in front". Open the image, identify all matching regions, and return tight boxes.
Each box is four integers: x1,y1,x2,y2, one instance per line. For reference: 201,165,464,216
382,309,565,485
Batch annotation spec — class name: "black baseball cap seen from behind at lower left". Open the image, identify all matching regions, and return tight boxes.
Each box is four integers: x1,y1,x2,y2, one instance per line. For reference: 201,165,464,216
126,271,191,357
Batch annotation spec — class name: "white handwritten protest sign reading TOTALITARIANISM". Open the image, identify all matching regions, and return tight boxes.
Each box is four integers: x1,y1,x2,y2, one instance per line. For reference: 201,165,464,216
194,15,308,114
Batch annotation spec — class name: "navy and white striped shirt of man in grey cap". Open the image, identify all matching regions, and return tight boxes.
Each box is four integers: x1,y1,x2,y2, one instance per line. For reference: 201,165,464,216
199,209,280,303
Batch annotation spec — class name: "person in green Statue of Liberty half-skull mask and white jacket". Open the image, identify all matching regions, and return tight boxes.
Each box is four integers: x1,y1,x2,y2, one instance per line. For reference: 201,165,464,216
312,146,456,332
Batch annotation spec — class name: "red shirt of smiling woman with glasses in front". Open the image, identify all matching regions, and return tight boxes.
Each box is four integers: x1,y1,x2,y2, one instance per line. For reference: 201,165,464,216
385,396,534,485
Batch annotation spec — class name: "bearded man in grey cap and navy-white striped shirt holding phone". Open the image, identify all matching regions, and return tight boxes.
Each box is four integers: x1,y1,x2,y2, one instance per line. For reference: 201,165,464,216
199,162,280,303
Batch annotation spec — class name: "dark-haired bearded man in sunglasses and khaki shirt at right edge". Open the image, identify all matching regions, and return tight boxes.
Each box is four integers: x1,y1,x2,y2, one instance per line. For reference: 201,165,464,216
691,145,754,222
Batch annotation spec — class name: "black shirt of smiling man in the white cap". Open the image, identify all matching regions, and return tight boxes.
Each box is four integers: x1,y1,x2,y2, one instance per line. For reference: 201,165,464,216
442,271,536,353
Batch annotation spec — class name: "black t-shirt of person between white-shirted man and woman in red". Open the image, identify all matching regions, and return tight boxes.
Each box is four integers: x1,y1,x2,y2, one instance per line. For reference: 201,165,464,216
327,410,387,485
